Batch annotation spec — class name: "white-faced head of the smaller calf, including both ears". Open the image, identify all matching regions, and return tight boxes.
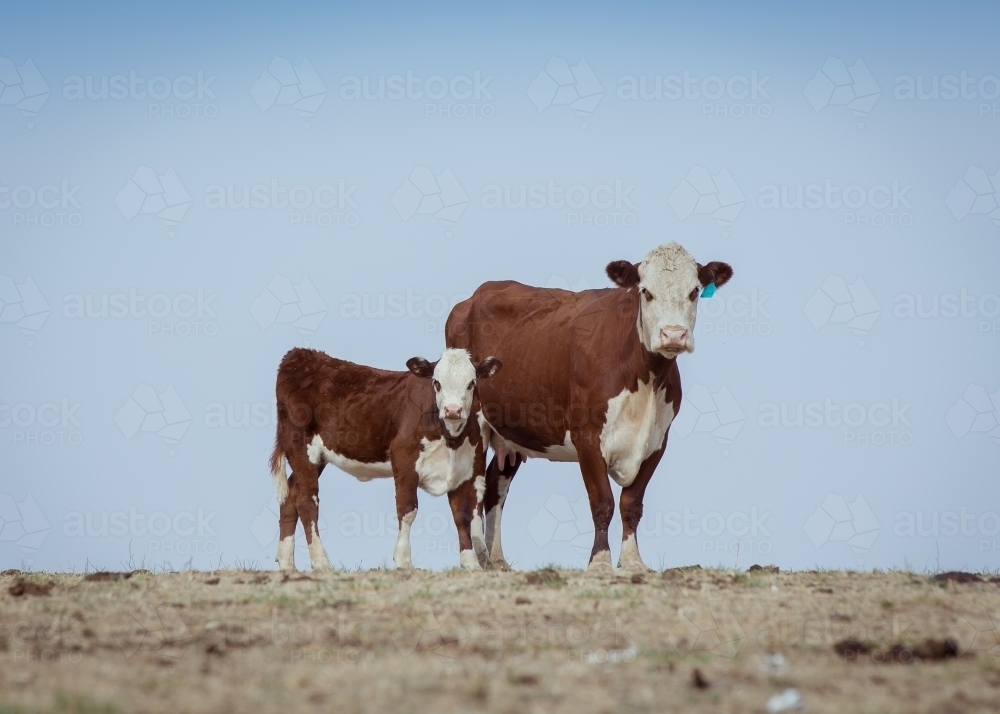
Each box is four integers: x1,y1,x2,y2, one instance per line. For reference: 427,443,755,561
406,349,503,436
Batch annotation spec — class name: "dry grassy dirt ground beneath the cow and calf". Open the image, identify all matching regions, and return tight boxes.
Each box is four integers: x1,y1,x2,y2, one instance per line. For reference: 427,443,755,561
0,568,1000,714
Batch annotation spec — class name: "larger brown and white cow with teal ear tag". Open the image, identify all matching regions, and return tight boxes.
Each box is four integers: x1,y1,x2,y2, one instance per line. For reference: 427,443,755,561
446,243,733,570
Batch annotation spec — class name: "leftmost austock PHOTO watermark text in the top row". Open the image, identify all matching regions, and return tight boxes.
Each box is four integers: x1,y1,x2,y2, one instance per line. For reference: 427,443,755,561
62,69,219,119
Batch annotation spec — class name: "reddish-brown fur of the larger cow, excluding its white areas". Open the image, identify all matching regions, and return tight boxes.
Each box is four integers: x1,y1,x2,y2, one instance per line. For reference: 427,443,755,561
445,253,732,557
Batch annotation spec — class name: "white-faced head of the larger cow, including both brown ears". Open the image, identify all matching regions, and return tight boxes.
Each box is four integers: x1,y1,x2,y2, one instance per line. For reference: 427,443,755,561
608,243,733,358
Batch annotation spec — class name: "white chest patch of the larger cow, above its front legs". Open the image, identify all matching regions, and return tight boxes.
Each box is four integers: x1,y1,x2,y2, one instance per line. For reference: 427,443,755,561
601,375,674,487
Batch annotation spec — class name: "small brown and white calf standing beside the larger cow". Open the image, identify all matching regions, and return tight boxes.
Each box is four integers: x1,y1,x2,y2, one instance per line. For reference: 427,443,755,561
271,349,502,570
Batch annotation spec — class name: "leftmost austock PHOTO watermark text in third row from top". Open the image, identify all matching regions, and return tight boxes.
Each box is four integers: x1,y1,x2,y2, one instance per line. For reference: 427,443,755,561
62,287,219,337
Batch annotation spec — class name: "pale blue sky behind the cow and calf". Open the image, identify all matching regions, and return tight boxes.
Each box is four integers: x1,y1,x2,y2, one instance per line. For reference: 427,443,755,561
0,3,1000,569
